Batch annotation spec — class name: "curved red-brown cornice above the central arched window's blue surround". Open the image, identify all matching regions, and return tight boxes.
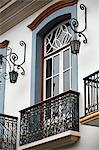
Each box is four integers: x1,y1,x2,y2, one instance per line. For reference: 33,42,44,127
27,0,78,30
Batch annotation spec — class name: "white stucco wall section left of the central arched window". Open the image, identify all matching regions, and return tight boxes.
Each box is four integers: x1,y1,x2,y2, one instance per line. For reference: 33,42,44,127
0,0,59,116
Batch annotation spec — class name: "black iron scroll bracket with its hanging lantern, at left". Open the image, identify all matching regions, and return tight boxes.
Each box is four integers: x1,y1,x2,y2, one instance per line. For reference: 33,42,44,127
0,41,26,83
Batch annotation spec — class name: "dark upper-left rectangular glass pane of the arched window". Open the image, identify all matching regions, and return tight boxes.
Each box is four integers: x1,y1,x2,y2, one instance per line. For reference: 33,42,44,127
46,58,52,78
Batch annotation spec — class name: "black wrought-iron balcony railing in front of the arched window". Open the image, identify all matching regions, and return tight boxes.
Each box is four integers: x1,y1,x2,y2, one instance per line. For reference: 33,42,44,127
20,90,79,145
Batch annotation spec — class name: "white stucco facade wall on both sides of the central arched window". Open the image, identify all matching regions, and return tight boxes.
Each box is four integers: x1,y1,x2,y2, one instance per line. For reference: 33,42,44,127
0,0,99,150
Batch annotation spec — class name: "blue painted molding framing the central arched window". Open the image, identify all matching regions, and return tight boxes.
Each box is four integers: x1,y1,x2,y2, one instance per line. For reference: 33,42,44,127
30,4,78,105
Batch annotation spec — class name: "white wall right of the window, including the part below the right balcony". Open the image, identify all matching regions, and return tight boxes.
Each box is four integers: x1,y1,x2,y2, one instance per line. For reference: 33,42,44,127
77,0,99,150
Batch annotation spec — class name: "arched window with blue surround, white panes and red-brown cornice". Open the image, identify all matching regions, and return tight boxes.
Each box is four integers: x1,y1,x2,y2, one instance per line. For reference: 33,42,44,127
28,0,78,105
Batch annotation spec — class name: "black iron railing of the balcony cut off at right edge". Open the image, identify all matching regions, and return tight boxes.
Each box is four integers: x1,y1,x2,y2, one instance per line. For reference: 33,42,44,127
84,71,99,116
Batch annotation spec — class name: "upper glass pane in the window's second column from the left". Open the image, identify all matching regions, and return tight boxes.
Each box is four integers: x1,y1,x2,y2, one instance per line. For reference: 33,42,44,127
53,55,59,75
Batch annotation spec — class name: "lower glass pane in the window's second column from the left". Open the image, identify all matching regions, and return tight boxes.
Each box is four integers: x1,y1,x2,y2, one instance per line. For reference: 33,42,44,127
53,76,59,96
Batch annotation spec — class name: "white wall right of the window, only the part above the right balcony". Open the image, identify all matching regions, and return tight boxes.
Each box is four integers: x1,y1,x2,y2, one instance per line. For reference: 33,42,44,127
78,0,99,116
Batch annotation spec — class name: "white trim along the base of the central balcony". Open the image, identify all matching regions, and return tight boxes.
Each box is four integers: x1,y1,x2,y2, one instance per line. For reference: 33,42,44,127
19,130,80,150
